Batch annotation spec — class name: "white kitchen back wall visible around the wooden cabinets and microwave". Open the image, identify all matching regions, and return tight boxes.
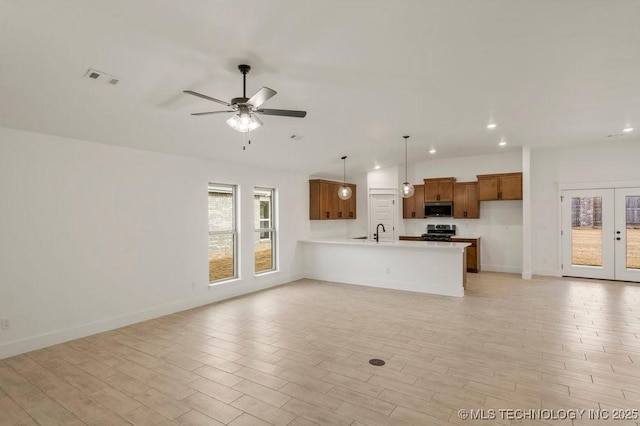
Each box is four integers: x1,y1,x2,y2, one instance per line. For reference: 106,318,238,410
400,151,522,273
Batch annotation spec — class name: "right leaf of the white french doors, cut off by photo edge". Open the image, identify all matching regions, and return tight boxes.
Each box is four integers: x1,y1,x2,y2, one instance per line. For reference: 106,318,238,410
614,188,640,282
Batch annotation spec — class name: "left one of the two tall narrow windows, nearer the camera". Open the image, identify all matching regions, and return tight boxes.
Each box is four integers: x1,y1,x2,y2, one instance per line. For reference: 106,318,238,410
209,183,238,282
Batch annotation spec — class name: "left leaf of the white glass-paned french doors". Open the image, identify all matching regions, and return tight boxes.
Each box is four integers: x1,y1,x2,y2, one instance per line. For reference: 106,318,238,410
561,189,615,280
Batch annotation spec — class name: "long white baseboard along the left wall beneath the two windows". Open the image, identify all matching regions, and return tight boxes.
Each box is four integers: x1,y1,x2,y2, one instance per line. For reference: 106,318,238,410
0,273,304,359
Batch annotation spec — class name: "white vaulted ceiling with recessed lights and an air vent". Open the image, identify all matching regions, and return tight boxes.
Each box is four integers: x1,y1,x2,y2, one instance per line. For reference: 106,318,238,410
0,0,640,180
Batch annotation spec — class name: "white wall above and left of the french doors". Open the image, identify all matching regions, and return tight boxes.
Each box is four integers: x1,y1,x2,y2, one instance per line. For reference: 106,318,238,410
531,137,640,275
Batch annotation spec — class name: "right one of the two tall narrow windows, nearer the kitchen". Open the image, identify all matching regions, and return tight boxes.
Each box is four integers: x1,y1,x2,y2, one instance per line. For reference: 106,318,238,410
253,188,276,274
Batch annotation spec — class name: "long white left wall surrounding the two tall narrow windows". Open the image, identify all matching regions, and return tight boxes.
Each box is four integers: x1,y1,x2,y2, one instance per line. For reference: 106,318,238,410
0,128,309,358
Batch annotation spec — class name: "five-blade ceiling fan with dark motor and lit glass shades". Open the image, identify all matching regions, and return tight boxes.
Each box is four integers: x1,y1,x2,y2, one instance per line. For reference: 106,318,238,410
184,65,307,133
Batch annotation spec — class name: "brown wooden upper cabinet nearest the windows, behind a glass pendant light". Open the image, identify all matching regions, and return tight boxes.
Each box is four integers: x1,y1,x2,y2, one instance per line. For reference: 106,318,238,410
309,179,356,220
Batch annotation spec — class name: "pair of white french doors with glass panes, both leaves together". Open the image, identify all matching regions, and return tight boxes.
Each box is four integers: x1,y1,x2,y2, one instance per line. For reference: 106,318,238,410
561,188,640,282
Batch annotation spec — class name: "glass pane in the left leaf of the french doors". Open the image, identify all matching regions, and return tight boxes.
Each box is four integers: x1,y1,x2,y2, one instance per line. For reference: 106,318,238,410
571,197,602,266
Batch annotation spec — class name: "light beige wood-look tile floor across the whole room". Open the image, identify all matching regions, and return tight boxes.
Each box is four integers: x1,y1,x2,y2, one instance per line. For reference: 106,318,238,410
0,273,640,426
